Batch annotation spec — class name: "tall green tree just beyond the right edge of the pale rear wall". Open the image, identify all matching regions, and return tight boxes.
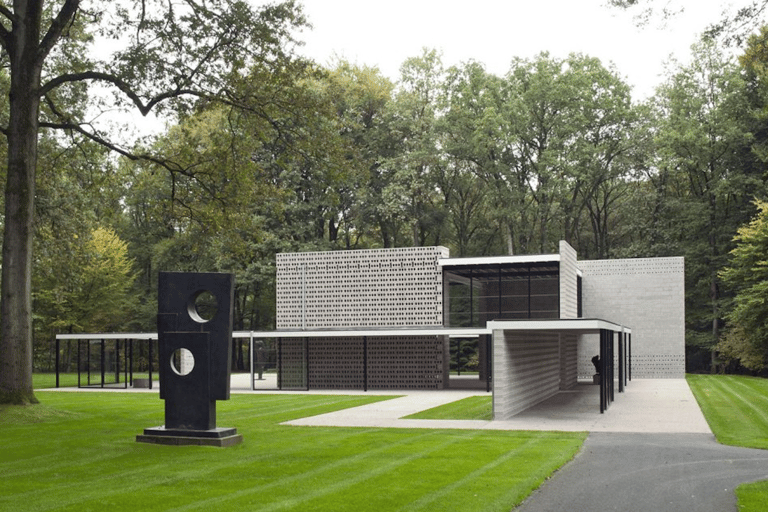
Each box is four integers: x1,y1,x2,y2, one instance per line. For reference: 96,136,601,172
656,41,762,368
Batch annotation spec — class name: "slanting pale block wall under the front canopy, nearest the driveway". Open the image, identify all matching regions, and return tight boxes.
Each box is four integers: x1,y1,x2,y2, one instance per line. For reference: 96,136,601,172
493,330,562,420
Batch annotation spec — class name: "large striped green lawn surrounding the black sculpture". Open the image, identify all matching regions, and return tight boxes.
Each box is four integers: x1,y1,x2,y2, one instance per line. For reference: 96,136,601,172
0,391,585,512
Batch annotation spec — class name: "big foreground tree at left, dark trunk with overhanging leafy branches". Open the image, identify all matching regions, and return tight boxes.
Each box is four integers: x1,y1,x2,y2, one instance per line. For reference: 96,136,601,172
0,0,304,403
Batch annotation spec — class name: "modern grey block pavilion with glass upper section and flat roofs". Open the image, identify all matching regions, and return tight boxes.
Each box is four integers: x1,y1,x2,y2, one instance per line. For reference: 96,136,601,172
268,242,685,419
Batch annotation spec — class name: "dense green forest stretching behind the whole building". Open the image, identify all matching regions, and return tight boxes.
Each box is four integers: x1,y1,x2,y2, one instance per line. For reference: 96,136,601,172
7,4,768,372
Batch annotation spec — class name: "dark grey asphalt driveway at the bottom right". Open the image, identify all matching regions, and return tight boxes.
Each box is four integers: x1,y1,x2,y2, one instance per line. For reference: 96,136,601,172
515,433,768,512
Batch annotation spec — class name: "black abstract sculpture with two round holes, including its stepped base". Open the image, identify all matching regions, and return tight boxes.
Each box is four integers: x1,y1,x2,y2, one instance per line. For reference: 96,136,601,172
136,272,242,446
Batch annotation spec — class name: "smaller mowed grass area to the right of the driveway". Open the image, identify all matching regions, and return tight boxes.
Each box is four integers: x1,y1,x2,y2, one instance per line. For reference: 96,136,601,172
688,375,768,512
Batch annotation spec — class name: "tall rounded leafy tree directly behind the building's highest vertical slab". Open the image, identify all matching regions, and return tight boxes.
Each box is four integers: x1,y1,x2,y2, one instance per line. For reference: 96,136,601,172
500,53,634,257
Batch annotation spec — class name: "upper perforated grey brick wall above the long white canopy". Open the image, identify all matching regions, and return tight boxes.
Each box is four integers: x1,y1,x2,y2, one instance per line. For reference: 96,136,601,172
277,247,448,329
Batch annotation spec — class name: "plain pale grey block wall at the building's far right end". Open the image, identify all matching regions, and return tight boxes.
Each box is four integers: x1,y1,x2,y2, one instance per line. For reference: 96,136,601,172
578,258,685,378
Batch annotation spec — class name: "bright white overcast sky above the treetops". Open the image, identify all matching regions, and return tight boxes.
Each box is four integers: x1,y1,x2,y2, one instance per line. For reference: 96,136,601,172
288,0,736,99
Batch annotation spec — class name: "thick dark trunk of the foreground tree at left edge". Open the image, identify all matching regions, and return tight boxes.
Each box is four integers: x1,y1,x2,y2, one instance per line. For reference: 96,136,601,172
0,5,41,404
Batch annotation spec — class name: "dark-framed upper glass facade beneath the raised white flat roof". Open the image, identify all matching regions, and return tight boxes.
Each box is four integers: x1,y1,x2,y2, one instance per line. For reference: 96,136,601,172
443,262,560,327
